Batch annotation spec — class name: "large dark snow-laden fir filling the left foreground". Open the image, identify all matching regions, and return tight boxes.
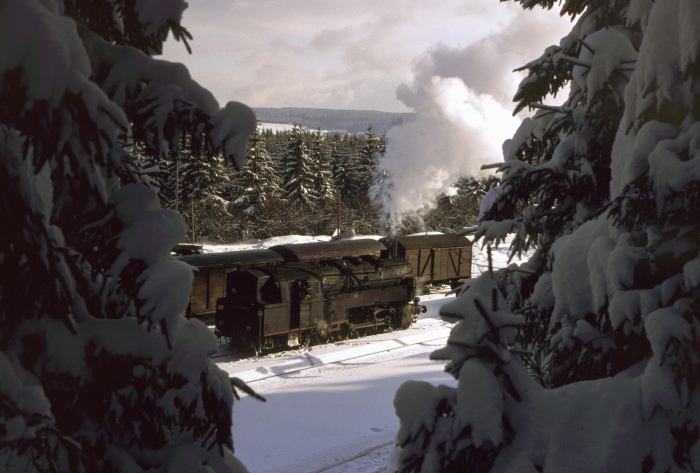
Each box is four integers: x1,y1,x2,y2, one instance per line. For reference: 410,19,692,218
0,0,255,472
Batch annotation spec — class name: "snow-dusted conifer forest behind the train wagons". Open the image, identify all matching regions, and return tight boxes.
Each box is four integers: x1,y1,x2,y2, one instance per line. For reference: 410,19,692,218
135,125,497,243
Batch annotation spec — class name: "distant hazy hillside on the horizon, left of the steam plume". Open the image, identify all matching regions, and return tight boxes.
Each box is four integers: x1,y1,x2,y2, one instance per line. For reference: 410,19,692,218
253,107,415,136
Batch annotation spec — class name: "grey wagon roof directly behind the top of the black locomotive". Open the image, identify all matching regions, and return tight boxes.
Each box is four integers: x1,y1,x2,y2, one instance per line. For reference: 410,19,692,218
270,238,386,262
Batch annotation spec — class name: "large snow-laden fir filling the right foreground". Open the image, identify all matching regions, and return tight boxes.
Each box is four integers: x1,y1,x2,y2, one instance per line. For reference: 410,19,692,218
395,0,700,473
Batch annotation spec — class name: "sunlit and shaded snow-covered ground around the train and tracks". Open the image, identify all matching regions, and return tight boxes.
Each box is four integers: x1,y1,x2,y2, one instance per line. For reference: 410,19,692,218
204,235,532,473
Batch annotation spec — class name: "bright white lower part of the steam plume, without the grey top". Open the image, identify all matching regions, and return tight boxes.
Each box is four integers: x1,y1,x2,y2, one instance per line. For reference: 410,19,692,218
373,76,520,226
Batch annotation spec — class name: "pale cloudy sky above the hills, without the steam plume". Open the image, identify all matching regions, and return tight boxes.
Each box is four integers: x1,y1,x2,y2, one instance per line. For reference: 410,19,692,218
163,0,566,112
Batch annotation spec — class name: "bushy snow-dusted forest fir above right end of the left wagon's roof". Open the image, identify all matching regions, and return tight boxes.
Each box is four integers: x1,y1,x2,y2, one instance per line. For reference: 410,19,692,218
230,125,281,214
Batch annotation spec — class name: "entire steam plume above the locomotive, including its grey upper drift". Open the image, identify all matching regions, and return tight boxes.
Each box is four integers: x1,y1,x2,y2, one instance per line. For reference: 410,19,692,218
372,11,571,231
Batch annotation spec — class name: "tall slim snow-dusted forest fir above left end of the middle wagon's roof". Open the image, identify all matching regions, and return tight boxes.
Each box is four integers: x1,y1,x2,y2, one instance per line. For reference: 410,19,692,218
280,125,314,207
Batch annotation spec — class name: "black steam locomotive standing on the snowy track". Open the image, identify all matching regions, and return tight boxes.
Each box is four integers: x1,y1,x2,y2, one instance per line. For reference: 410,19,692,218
215,239,420,353
